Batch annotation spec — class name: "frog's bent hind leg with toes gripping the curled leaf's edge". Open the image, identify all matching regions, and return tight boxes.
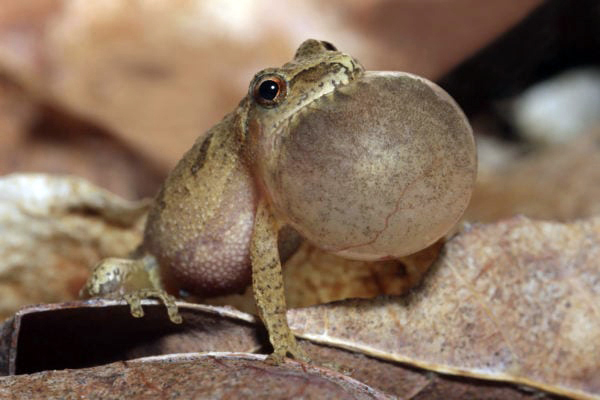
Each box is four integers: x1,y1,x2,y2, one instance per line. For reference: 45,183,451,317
79,255,182,324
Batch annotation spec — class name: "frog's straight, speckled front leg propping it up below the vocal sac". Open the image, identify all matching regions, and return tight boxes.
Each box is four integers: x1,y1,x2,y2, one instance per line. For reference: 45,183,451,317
250,199,310,364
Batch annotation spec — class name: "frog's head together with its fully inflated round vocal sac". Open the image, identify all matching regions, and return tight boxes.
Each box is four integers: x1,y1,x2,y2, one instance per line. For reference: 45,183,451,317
238,40,477,260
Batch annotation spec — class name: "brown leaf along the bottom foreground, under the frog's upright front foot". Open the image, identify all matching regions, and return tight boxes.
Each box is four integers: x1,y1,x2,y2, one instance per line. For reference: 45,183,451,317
0,353,389,399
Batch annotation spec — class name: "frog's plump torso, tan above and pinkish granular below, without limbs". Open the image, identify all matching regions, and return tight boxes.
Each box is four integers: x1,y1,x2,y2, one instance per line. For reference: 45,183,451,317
144,113,256,296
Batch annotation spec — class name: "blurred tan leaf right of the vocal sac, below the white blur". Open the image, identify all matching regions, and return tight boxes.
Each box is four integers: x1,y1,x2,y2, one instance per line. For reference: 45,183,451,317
465,129,600,221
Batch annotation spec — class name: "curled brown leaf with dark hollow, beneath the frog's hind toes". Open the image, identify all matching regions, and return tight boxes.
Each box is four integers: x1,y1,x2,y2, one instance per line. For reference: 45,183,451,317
0,299,268,376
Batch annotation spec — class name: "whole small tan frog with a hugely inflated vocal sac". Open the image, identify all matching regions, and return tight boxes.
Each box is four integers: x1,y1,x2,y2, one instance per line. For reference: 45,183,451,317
82,39,477,364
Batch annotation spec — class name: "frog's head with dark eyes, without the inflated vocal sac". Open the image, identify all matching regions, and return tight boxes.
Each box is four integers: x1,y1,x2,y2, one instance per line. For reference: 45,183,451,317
244,39,364,155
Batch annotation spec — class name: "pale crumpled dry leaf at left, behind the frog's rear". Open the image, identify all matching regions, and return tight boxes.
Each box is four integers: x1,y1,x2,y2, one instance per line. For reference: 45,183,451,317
0,174,148,317
